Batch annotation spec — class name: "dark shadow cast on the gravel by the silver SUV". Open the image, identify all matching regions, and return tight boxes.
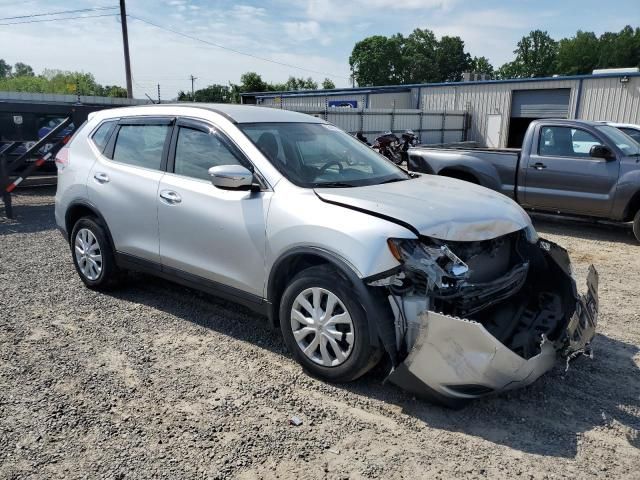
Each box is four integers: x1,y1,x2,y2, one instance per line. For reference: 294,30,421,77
104,275,640,458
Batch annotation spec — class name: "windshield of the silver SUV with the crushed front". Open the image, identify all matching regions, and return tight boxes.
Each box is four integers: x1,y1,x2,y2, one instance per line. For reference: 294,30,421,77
239,123,411,188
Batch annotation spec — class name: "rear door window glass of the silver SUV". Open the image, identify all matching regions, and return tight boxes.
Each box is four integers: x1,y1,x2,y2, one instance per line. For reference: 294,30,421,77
113,125,171,170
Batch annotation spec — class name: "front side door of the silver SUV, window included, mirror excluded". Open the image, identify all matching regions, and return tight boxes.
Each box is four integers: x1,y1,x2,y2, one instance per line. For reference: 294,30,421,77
158,119,271,297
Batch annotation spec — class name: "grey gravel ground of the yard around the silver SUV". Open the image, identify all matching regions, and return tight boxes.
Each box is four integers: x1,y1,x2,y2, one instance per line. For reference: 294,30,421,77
0,188,640,479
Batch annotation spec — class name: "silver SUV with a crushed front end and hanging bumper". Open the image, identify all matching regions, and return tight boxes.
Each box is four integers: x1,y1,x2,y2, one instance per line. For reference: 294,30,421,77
56,104,597,405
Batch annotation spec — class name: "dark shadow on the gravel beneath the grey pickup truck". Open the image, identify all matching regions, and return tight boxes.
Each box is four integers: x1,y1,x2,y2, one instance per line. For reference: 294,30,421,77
529,212,638,245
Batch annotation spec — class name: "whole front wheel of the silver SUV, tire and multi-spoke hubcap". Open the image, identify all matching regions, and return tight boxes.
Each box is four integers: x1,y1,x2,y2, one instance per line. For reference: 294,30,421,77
280,266,381,382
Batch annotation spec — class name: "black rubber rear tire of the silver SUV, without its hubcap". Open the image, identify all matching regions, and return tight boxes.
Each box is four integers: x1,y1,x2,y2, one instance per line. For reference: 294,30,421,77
69,217,121,290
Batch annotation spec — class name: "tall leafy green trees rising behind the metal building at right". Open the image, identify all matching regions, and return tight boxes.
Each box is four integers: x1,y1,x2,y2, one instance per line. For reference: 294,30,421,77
349,26,640,86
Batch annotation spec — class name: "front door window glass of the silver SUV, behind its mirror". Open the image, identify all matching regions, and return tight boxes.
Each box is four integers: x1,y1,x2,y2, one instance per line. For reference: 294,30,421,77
173,127,241,180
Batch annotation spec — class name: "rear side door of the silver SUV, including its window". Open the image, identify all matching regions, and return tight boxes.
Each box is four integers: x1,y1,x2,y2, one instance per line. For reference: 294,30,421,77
88,117,174,265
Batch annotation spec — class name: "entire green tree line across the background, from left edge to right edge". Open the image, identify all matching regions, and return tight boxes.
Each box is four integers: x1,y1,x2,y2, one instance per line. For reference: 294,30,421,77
0,26,640,103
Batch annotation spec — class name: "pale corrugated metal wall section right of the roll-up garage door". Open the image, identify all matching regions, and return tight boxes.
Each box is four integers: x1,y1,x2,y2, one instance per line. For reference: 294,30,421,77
578,77,640,124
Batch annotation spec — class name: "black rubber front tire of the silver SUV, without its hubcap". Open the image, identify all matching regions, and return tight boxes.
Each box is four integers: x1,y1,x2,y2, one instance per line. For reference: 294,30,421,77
280,266,382,382
